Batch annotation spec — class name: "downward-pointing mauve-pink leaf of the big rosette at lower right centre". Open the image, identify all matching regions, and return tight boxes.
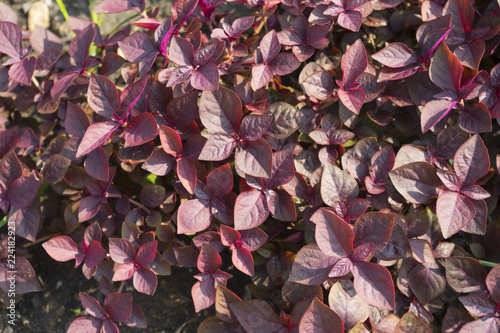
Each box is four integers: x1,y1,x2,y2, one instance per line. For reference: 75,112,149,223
352,261,395,310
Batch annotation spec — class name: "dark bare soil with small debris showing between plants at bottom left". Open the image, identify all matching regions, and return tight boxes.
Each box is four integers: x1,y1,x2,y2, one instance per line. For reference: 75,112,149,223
0,241,214,333
